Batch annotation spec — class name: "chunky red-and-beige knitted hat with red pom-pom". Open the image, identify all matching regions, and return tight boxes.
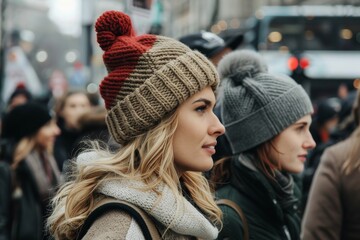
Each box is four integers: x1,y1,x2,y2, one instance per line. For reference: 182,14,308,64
95,11,219,144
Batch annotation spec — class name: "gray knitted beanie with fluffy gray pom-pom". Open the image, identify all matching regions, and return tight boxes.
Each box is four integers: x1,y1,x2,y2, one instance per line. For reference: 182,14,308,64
218,50,313,154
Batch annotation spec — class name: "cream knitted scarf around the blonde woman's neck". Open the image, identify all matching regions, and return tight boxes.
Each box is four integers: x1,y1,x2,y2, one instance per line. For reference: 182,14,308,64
77,152,218,239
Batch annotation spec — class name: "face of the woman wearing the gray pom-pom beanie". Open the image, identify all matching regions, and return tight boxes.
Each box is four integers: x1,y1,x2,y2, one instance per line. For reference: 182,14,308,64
270,114,316,173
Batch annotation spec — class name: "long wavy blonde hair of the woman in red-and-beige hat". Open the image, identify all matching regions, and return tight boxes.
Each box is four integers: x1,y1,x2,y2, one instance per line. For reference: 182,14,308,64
48,109,221,239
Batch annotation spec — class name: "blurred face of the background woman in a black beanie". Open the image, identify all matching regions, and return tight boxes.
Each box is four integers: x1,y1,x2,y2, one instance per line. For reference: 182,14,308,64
35,120,61,150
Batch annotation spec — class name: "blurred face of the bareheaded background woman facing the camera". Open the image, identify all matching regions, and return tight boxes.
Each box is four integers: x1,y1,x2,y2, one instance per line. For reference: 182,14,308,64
60,93,90,128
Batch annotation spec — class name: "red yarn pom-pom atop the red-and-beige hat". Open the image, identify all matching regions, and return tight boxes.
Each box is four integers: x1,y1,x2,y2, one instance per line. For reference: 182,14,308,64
95,11,135,51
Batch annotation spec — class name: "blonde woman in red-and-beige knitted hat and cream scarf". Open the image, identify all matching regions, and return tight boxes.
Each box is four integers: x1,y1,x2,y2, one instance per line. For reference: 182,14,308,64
48,11,224,239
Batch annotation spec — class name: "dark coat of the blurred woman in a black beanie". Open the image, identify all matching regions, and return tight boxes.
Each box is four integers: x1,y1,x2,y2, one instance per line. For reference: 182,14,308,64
0,152,62,240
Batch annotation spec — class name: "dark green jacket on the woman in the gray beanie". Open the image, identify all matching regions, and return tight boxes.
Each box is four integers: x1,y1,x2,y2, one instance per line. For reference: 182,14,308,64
216,157,301,240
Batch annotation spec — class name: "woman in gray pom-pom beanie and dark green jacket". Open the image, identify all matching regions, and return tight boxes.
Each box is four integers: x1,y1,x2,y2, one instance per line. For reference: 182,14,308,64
211,50,315,240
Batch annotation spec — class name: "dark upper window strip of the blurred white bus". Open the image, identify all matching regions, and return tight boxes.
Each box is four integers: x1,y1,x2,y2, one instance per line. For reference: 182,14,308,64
259,16,360,51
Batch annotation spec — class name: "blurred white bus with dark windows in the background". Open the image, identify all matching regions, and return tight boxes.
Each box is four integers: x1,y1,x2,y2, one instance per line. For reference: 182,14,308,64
244,6,360,99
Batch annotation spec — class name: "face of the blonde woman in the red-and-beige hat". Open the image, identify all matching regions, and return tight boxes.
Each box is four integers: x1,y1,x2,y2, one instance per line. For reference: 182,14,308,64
173,87,225,175
